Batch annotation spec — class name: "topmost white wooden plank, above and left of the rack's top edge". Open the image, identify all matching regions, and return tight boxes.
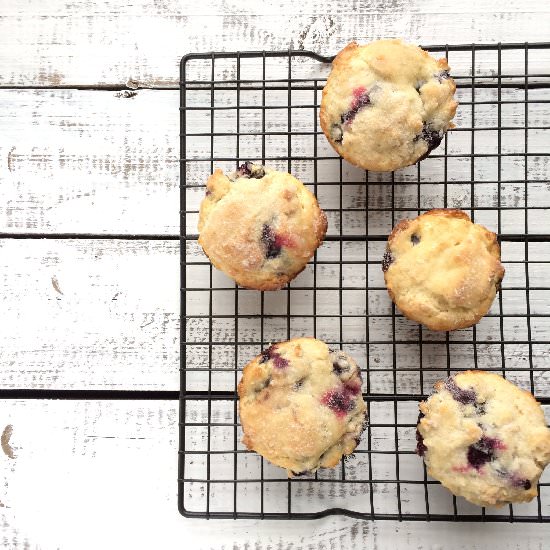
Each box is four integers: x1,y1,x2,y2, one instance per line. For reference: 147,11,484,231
0,0,550,87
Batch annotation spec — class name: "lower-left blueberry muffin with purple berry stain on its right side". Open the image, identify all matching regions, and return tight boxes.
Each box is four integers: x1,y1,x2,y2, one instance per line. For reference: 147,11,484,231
239,338,366,477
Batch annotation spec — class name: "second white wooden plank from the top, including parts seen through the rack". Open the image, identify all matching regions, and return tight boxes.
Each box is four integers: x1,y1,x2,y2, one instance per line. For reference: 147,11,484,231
0,89,550,235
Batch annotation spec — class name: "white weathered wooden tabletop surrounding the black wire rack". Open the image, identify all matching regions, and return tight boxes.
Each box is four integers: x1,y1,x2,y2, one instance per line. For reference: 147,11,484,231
0,0,550,549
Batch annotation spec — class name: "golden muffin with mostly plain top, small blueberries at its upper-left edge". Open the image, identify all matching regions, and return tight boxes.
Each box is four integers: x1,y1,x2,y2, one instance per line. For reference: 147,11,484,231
382,209,504,330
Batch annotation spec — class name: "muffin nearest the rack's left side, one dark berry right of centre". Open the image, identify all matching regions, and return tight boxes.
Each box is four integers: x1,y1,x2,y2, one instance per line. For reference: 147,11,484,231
199,162,327,290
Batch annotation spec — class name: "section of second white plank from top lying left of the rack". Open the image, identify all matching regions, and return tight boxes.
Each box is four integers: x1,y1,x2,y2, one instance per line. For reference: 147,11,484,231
0,91,179,234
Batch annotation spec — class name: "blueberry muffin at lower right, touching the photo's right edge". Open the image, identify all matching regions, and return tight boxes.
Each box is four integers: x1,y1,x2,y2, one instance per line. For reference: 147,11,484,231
417,371,550,506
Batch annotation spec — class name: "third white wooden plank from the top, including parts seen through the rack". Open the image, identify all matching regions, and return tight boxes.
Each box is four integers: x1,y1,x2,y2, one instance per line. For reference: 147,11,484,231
0,239,550,396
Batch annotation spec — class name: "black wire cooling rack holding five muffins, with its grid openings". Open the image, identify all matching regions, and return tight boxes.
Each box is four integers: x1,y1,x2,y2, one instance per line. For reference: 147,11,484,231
178,44,550,522
